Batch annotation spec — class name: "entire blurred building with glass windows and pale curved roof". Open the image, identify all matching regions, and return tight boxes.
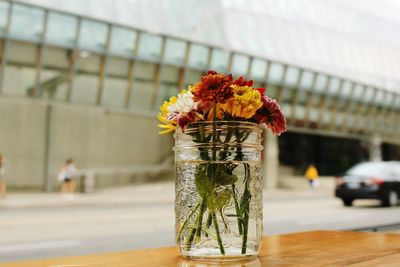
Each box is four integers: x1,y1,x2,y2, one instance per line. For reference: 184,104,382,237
0,0,400,189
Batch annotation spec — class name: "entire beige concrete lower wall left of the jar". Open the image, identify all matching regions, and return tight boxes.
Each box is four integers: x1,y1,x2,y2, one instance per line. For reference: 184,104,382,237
0,97,172,192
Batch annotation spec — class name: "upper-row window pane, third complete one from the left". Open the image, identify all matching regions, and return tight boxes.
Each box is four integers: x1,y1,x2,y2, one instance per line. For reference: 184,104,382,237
79,19,107,51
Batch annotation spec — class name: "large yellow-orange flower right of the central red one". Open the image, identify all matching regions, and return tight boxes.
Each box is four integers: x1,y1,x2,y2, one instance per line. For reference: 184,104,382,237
220,85,263,119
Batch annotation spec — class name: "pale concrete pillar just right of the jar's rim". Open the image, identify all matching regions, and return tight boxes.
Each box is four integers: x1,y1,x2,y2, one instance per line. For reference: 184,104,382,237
263,130,279,189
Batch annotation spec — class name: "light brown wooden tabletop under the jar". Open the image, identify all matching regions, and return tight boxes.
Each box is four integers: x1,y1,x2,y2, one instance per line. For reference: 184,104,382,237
0,231,400,267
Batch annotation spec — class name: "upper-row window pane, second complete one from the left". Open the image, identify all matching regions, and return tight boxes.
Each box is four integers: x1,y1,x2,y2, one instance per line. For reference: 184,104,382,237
46,13,78,46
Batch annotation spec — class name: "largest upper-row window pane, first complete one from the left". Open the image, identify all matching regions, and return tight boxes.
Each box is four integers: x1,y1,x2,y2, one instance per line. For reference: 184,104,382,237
10,4,44,40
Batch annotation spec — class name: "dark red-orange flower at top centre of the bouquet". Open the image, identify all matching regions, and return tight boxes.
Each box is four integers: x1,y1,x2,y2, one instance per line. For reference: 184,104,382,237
191,70,233,105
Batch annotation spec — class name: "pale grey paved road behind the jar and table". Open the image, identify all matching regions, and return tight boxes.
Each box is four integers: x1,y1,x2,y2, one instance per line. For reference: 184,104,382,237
0,183,400,262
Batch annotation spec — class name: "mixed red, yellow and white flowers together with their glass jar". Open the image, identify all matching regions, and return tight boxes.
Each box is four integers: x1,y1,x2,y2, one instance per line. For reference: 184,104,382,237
158,71,286,260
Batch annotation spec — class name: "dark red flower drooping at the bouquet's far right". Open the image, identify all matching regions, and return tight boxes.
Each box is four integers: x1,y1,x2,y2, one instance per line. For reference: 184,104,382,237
254,95,286,135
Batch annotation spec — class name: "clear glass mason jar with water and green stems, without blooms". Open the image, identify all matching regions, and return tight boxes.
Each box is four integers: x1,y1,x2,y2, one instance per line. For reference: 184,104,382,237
174,121,263,260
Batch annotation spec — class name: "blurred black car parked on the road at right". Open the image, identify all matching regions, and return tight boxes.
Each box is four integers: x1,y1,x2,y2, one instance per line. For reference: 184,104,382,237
335,161,400,206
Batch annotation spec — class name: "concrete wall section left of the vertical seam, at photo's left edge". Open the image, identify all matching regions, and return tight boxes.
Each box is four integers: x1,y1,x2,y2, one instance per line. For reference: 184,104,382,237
0,97,46,187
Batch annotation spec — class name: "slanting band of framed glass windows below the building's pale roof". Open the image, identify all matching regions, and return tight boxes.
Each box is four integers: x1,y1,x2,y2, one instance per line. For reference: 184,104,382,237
0,0,400,142
